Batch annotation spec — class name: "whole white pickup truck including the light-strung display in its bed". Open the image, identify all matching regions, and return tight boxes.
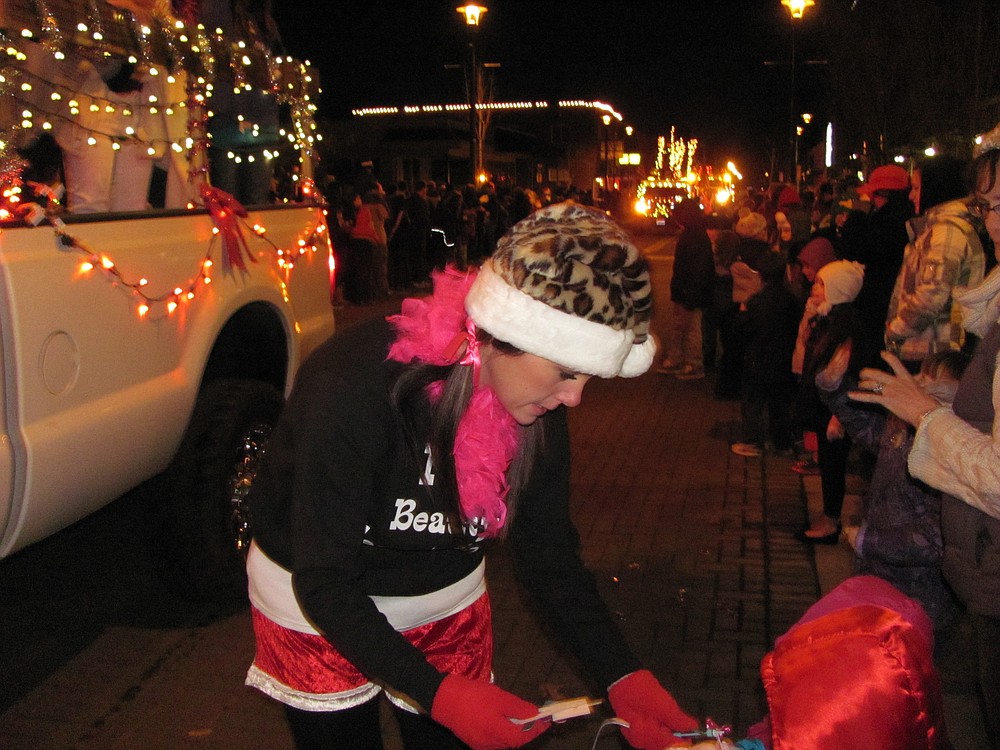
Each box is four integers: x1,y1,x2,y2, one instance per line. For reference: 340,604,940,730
0,0,334,597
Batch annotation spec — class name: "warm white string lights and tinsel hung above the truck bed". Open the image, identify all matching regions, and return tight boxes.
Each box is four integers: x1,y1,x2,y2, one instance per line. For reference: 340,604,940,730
0,0,321,212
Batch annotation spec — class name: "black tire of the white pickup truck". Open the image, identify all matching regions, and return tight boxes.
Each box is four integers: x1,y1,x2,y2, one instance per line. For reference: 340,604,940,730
159,379,282,605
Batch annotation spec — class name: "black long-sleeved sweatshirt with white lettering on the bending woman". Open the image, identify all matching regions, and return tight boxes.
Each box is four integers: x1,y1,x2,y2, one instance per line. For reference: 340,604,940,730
250,320,639,709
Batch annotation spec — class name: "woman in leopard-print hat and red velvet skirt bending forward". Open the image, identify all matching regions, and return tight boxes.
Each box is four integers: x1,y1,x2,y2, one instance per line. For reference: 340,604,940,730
247,203,696,750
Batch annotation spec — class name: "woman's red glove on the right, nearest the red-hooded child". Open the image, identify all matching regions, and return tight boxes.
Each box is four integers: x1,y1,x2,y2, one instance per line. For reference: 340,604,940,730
608,669,698,750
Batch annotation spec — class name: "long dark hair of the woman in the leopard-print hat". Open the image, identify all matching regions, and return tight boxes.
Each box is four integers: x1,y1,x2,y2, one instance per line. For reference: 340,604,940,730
389,329,545,537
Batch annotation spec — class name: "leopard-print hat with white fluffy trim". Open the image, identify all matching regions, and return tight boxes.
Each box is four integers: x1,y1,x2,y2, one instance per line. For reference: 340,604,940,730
465,202,656,378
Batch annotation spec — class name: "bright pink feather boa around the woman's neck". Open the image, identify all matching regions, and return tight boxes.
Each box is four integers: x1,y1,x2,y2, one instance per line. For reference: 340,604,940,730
388,266,518,538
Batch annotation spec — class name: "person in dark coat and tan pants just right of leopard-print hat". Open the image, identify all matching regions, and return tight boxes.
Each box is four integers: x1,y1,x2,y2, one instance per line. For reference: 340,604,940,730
657,200,715,380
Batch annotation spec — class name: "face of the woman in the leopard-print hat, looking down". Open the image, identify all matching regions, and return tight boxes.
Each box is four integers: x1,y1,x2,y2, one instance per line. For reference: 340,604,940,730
480,344,590,425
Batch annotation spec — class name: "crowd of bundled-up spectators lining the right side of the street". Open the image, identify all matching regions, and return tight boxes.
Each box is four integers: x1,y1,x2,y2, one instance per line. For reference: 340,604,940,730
676,156,1000,746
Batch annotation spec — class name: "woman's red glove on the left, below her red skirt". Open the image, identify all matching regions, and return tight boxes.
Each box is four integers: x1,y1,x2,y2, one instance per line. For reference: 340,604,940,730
431,674,551,750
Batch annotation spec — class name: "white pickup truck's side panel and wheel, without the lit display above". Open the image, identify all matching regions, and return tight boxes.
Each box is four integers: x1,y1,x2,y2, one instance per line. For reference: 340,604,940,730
0,204,334,594
